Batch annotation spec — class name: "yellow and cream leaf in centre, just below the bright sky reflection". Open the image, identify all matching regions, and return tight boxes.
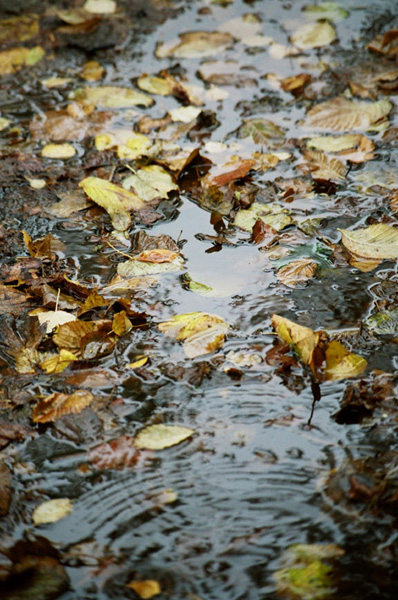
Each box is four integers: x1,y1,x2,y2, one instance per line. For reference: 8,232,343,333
158,312,229,358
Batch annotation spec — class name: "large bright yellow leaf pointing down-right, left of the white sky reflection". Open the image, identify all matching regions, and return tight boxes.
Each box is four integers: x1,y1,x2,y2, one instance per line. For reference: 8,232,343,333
79,177,145,231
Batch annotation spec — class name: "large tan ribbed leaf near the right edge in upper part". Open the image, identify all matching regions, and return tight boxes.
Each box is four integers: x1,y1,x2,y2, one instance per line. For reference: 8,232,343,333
304,97,392,131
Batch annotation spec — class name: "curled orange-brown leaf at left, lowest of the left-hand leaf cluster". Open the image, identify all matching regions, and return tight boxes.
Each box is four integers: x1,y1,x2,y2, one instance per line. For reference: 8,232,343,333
33,390,94,423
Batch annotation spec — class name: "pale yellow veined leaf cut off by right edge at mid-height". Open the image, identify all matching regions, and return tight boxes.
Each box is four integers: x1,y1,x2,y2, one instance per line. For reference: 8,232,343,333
339,223,398,260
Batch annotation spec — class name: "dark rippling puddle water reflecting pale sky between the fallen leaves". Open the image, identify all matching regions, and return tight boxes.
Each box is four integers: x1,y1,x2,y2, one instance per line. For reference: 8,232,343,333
5,0,398,600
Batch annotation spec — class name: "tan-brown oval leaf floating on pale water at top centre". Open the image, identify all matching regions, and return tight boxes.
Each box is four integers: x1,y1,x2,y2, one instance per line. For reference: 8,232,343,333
155,31,234,58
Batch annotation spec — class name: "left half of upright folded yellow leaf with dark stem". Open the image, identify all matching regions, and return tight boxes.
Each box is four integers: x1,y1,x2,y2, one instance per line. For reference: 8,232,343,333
271,315,321,367
